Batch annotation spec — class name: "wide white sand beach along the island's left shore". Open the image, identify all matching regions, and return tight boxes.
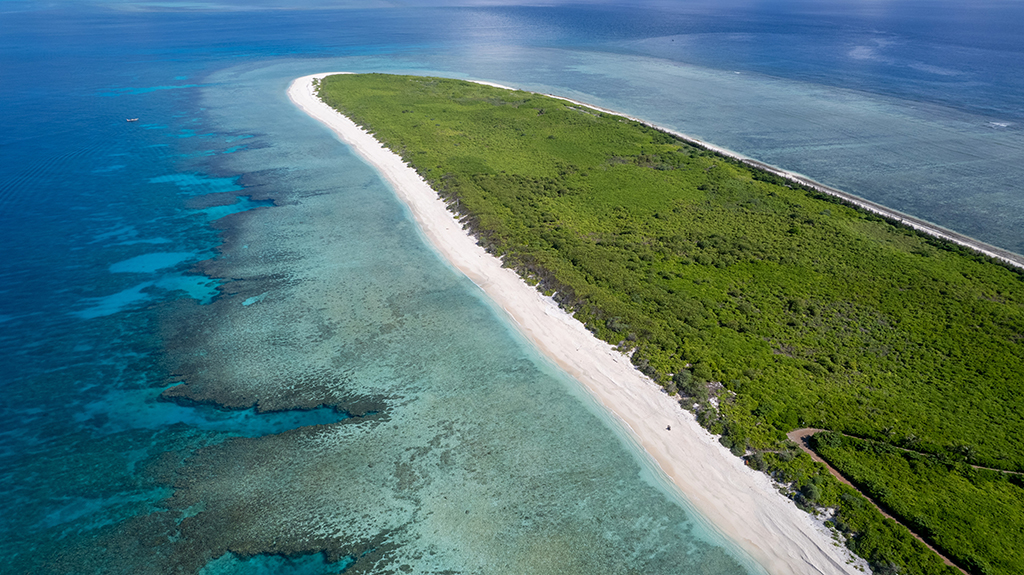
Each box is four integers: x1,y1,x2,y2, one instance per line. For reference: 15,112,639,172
288,74,860,575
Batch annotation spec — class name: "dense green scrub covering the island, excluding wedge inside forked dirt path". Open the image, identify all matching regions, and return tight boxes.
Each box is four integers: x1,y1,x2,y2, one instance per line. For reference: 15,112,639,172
321,75,1024,573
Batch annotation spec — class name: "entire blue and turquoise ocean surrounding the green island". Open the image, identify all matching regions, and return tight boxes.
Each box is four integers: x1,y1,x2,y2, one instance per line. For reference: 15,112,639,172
0,0,1024,574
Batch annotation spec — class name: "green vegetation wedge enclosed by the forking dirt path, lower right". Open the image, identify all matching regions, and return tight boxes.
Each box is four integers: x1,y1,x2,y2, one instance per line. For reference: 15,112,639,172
813,432,1024,575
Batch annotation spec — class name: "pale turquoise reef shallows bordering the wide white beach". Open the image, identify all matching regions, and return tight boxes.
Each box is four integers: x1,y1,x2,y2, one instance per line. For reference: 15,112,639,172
151,62,758,573
